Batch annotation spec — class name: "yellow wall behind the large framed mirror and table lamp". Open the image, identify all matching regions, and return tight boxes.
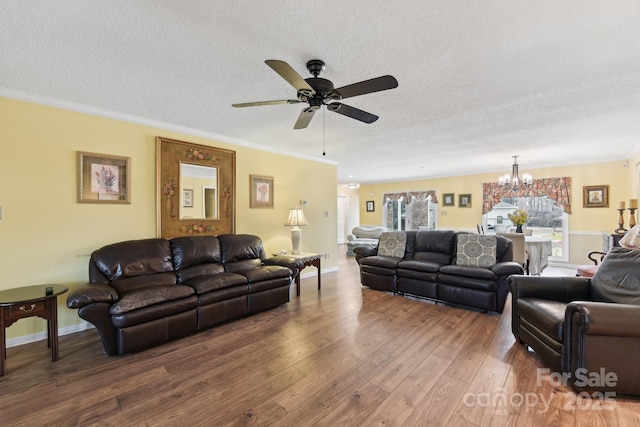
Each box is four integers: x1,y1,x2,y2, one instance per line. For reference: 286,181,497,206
0,97,337,338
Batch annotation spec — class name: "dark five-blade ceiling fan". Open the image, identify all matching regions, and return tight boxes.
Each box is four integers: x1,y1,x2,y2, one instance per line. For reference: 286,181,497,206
233,59,398,129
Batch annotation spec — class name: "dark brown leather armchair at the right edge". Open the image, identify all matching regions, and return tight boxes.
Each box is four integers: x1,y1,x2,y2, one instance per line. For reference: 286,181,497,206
508,247,640,394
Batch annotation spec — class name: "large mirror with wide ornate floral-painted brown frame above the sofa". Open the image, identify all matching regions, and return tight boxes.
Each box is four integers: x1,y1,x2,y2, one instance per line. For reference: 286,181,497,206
156,137,236,239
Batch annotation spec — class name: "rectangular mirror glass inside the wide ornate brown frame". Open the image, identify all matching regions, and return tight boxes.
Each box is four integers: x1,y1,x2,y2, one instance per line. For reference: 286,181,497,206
180,162,219,219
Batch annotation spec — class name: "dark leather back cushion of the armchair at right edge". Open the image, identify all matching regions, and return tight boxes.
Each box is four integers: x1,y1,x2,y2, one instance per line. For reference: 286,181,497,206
591,247,640,305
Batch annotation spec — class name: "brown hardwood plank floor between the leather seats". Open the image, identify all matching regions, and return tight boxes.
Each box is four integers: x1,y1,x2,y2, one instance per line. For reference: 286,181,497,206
0,251,640,426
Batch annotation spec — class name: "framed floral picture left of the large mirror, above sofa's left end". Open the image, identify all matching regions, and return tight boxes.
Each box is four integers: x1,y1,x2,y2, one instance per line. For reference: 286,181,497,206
78,151,131,203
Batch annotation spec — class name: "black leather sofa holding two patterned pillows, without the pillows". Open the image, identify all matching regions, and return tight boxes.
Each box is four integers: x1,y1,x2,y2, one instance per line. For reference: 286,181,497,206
355,230,524,313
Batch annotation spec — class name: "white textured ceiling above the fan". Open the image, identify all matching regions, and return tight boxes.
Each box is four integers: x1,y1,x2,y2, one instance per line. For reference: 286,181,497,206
0,0,640,183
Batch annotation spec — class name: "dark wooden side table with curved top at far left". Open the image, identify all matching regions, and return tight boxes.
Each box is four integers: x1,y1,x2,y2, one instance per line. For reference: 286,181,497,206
0,285,69,377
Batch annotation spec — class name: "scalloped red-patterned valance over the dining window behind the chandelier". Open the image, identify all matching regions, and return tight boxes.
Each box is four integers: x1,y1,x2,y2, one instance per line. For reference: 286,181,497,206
482,177,571,214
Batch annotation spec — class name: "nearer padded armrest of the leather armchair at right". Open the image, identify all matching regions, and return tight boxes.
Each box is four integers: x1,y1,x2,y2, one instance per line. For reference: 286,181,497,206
565,301,640,337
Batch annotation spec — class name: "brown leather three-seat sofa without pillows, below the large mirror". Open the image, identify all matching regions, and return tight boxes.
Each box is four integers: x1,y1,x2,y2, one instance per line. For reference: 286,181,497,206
67,234,299,355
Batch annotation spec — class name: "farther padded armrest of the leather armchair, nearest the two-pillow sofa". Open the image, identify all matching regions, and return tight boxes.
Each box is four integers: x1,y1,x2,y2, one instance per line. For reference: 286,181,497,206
507,275,591,303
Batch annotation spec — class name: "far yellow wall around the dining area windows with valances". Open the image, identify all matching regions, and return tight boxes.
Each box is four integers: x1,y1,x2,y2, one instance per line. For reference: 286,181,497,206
360,161,640,264
